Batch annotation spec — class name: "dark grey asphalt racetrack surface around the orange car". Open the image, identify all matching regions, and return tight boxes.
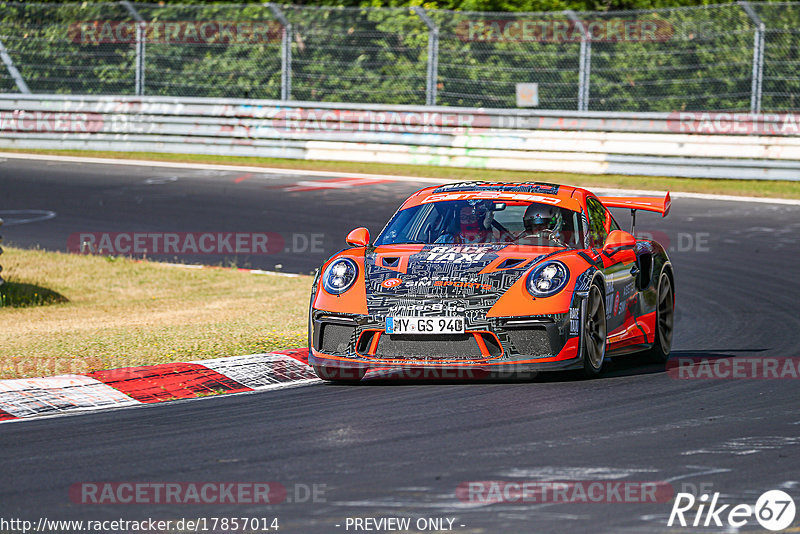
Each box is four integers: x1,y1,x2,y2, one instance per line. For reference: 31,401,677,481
0,159,800,533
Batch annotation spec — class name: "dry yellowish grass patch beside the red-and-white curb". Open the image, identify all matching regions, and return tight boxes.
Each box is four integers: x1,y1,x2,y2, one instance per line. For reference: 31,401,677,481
0,247,311,378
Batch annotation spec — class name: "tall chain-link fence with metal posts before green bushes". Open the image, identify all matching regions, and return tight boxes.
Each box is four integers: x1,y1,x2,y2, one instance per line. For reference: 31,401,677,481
0,2,800,112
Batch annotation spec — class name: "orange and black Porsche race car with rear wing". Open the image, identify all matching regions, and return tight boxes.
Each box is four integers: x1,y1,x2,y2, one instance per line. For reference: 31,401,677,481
309,182,675,382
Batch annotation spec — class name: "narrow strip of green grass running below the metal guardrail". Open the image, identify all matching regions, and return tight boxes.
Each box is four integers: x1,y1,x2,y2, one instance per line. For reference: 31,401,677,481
0,150,800,199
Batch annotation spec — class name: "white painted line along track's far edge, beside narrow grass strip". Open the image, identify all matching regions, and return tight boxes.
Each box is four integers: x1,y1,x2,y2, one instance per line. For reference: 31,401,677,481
3,152,800,206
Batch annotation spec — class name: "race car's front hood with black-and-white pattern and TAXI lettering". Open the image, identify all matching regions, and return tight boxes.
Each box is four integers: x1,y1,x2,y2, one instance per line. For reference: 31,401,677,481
365,244,564,311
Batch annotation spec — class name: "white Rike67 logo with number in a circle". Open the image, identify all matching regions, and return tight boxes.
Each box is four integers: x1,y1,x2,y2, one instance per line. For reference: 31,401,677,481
667,490,796,532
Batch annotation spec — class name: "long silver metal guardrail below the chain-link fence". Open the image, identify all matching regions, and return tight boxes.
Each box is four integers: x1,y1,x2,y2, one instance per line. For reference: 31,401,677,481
0,95,800,180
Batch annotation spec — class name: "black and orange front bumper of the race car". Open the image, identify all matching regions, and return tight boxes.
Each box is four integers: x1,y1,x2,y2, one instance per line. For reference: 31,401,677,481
309,310,582,377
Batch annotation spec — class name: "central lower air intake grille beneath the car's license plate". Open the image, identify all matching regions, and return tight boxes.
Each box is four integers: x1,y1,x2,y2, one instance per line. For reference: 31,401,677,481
368,333,502,360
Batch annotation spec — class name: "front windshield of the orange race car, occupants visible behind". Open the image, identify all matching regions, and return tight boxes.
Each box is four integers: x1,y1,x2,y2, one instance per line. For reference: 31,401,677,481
375,200,582,248
